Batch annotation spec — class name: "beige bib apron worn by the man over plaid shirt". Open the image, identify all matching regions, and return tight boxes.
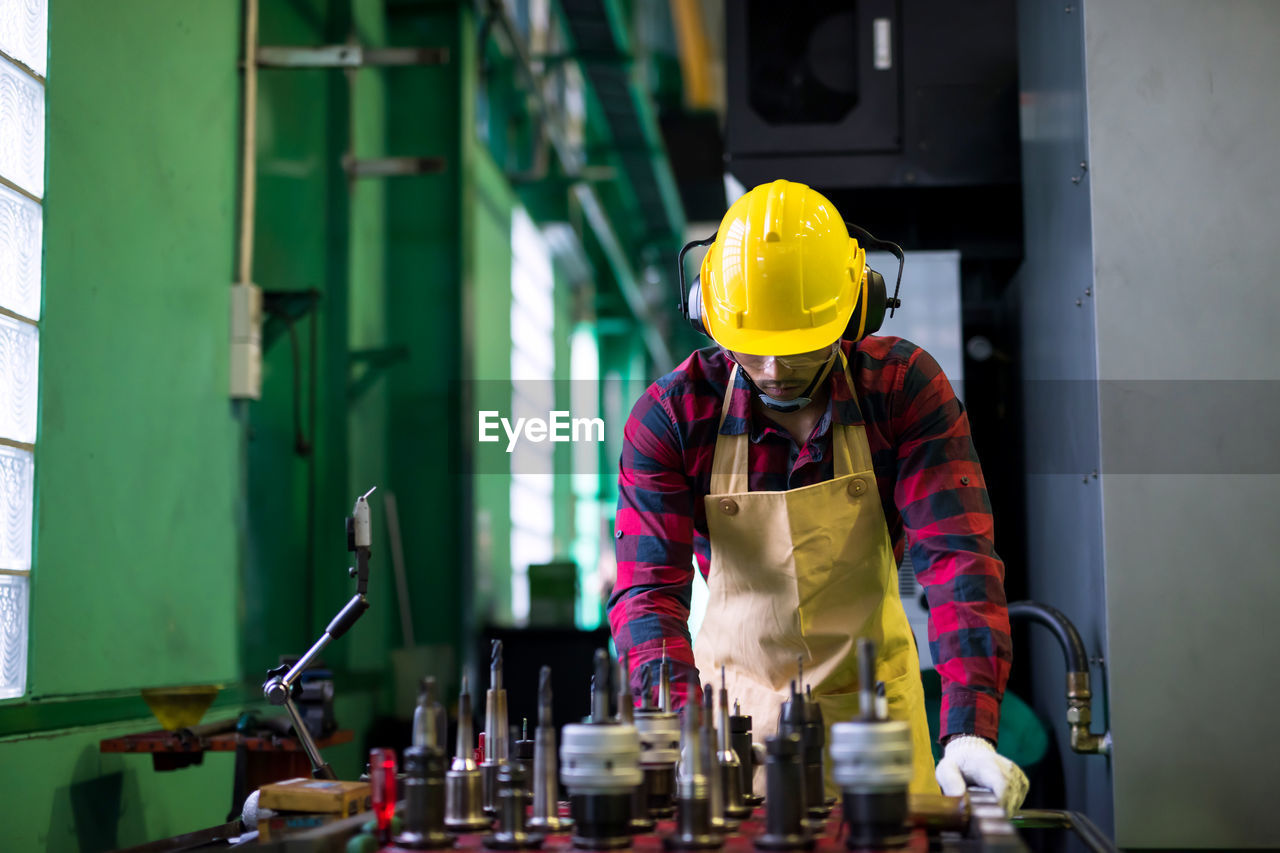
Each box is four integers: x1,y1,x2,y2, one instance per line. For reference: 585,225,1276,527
694,355,938,795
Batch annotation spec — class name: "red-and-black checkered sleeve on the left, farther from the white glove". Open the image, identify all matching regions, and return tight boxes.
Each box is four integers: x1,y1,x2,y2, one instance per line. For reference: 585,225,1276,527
608,386,698,706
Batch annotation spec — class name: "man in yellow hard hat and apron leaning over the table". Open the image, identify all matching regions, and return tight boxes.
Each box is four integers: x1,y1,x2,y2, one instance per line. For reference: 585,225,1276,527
609,181,1027,812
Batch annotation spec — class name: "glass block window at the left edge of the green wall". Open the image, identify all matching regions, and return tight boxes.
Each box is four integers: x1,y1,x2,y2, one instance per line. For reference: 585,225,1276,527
0,0,49,699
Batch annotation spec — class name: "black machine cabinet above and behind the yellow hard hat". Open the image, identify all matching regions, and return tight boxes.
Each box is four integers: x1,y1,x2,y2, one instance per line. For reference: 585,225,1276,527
724,0,1020,188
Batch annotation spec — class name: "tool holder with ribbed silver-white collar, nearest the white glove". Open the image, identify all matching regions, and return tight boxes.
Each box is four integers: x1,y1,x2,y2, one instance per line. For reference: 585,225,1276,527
831,639,911,850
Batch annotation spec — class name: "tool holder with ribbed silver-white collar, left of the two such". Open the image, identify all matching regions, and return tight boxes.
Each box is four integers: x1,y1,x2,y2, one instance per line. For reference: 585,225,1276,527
561,649,644,850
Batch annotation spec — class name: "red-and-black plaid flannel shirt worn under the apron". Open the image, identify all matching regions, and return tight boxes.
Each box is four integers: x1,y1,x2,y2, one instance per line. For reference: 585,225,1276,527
608,337,1012,742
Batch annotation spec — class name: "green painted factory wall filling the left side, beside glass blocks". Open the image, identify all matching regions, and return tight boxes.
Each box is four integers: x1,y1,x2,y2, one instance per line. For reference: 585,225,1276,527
0,0,686,850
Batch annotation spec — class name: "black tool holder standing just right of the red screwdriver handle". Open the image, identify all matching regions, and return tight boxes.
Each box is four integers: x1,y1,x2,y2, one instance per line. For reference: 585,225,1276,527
393,678,453,850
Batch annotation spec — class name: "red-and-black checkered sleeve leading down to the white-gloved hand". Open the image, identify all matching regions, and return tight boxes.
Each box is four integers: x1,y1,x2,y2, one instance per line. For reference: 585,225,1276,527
890,348,1012,742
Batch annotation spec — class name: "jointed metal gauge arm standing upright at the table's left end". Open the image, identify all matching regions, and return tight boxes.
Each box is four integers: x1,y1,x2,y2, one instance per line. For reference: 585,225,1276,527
262,487,378,779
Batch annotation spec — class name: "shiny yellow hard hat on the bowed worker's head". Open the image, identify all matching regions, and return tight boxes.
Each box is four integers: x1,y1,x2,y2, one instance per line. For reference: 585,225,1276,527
700,181,867,355
